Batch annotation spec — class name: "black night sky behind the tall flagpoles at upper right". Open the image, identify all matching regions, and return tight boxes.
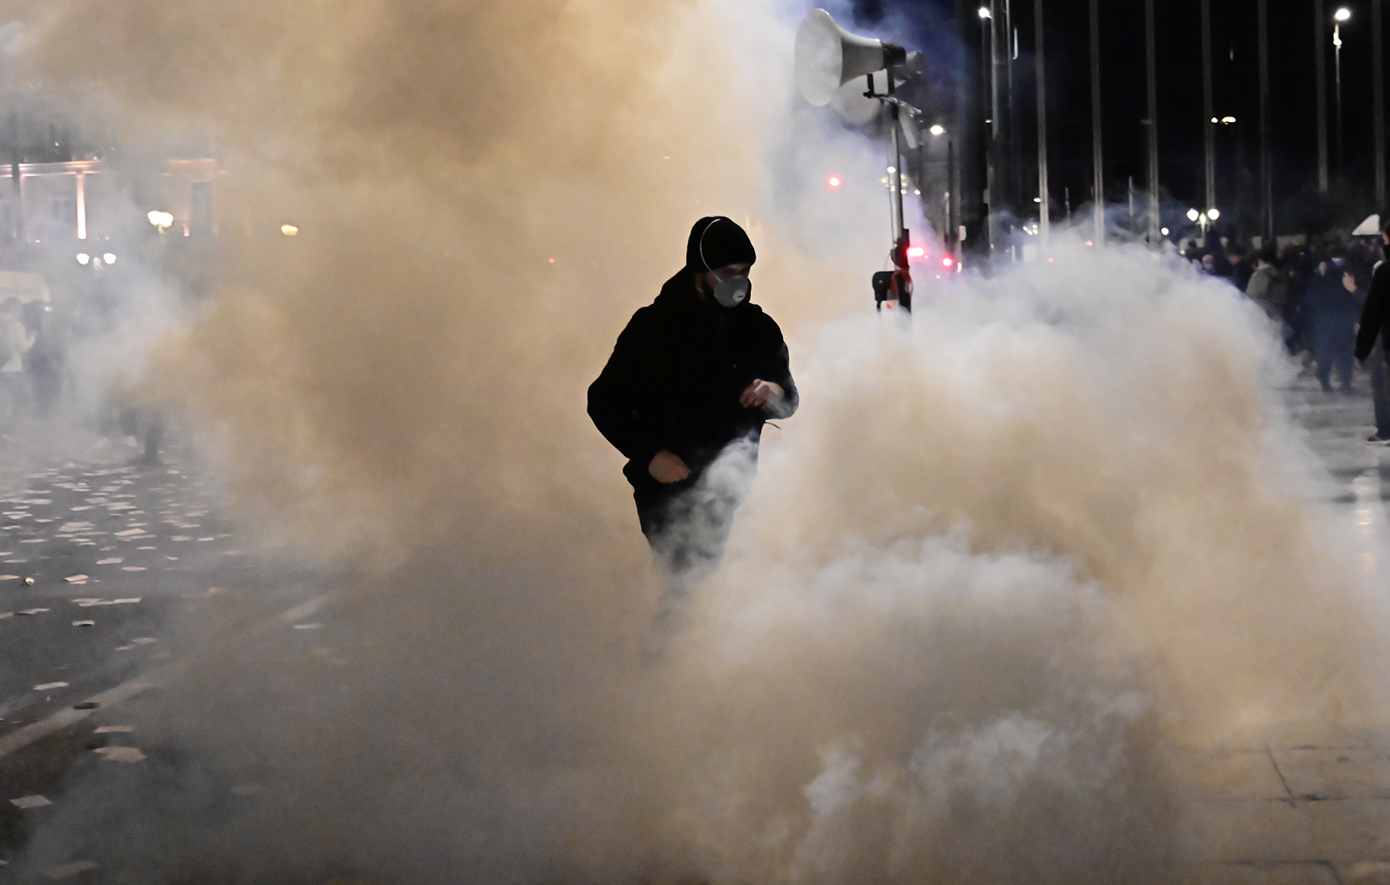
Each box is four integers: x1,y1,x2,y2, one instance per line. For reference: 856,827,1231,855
845,0,1390,232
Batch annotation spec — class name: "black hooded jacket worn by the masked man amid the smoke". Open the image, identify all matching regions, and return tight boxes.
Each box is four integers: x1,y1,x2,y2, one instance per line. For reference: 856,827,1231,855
589,268,798,488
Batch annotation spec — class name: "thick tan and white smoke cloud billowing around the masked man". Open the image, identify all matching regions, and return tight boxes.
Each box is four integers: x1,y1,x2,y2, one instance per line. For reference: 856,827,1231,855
10,0,1383,884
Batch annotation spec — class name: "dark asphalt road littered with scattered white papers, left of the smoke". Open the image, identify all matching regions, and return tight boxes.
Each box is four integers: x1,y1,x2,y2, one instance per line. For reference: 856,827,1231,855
0,430,341,882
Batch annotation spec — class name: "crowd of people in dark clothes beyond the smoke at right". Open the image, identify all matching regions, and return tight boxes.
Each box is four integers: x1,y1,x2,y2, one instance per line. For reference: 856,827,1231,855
1184,225,1390,445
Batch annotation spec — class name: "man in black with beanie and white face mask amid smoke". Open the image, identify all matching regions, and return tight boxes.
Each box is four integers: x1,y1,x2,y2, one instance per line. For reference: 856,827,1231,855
589,215,798,586
